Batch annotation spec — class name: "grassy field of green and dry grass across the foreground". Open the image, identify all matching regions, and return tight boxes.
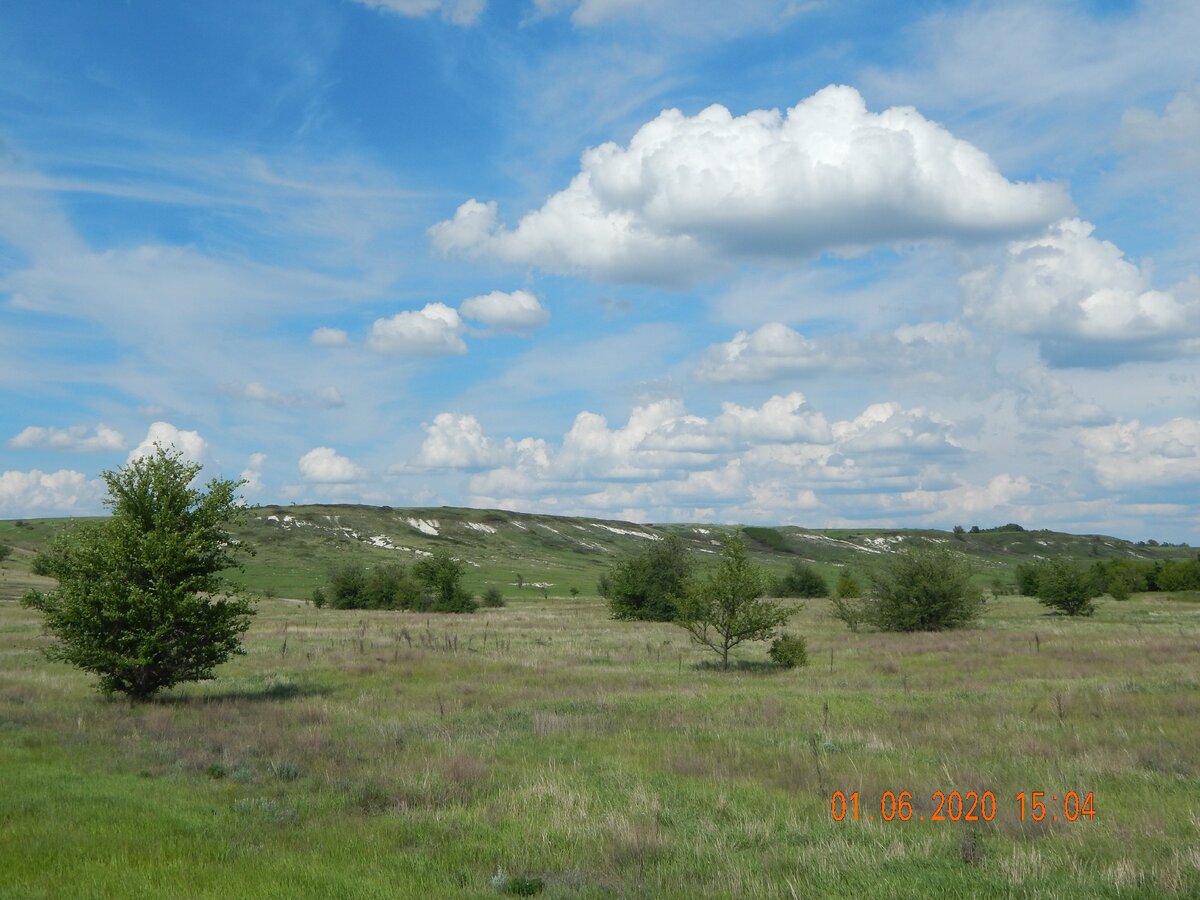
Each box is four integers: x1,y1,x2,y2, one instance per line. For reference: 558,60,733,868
0,532,1200,899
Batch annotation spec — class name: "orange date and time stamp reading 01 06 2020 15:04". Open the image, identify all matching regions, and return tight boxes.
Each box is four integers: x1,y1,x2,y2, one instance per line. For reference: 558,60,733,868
829,791,1096,822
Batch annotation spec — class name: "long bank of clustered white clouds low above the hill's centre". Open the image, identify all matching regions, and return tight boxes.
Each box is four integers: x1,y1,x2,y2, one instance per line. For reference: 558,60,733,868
432,392,960,518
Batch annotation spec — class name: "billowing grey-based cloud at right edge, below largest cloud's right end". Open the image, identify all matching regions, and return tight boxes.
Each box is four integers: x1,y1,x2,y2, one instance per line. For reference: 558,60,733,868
962,218,1200,366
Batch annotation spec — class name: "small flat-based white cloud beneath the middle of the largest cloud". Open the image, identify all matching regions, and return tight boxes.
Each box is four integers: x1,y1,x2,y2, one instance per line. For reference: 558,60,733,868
695,322,829,384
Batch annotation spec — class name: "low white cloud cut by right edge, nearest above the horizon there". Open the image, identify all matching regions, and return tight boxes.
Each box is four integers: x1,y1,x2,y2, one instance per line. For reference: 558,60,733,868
1080,416,1200,490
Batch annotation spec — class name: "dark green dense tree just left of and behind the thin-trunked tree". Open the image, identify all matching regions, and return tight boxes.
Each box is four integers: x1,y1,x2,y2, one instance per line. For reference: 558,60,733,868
598,534,695,622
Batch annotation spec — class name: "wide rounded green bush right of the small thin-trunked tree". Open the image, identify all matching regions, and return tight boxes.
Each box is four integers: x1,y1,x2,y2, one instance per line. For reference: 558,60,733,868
869,548,983,631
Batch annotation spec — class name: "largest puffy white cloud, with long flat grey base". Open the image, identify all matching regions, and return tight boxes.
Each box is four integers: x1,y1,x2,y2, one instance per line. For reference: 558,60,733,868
430,86,1070,286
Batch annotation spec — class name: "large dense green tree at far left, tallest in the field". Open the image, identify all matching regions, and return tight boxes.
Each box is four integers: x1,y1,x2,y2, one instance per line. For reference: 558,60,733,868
24,445,253,700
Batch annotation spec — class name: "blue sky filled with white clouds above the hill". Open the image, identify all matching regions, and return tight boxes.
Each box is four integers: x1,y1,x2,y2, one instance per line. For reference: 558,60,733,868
0,0,1200,544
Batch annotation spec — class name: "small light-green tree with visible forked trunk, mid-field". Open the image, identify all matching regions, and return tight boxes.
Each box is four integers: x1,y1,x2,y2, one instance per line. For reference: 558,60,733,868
676,536,792,668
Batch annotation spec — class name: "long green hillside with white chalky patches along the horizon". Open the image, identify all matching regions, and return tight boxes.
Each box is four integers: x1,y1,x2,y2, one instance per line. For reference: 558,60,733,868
0,505,1194,607
